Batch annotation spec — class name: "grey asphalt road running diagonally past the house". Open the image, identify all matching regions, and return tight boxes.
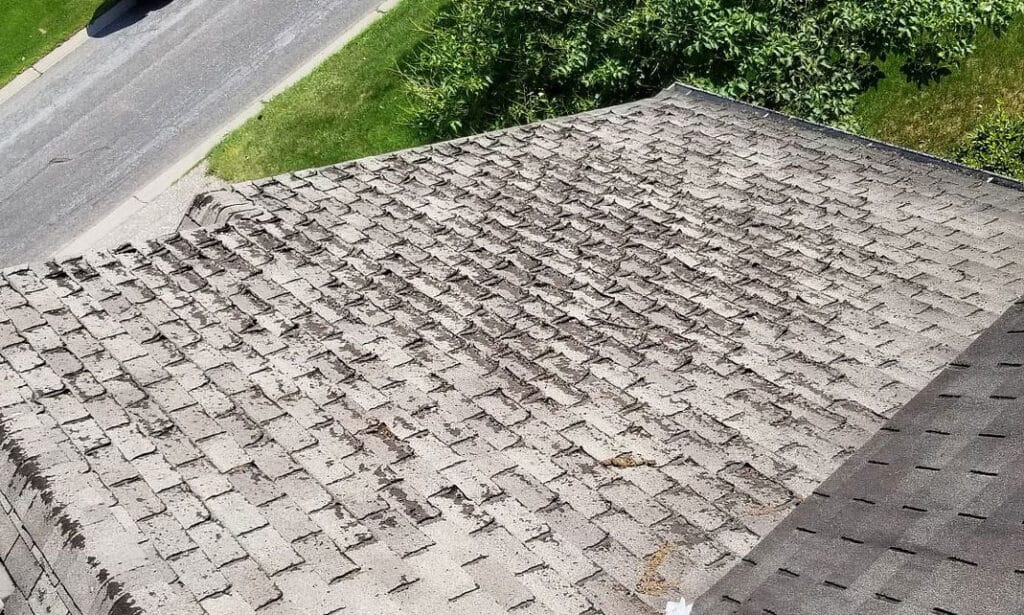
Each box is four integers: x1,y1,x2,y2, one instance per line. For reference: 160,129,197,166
0,0,379,266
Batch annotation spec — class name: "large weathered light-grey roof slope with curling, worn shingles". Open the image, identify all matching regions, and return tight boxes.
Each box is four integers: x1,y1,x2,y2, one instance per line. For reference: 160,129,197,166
0,86,1024,615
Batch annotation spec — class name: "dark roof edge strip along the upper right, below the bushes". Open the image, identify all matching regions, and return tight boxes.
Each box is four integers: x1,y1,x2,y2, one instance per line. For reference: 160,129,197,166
654,82,1024,192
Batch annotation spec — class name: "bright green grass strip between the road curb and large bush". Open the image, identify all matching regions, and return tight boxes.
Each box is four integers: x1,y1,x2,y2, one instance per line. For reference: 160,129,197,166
209,0,447,181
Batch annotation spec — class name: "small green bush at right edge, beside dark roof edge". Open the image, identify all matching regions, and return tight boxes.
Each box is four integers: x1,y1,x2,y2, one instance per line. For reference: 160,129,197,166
956,106,1024,179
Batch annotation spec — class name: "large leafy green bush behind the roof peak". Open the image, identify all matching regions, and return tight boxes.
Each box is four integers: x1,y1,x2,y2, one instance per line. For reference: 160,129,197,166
409,0,1020,137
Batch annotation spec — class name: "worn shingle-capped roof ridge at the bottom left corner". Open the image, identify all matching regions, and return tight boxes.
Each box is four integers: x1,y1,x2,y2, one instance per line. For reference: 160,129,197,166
0,402,189,615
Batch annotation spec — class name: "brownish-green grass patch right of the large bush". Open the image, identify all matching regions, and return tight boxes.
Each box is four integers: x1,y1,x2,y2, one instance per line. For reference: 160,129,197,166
856,19,1024,158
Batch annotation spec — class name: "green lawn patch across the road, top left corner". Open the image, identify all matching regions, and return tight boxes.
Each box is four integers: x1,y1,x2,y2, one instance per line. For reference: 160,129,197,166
0,0,113,86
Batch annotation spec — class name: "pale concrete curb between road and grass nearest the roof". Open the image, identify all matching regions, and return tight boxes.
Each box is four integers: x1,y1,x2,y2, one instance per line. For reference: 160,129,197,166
52,0,400,259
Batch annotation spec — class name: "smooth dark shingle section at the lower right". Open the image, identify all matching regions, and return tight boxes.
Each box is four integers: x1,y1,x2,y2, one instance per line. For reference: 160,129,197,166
696,294,1024,615
